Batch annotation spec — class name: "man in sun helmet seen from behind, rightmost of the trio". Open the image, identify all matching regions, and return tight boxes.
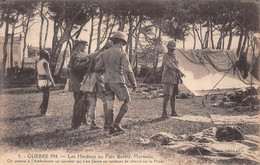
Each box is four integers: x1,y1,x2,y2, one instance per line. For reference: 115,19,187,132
95,31,137,134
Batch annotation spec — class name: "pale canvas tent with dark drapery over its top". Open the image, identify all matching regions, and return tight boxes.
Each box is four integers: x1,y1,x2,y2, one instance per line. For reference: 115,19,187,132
175,49,260,95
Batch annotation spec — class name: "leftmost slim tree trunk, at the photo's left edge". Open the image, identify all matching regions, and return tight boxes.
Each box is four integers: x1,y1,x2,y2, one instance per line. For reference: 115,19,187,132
1,12,10,75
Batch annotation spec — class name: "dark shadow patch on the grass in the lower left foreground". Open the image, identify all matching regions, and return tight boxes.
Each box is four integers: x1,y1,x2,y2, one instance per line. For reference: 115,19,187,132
2,128,109,150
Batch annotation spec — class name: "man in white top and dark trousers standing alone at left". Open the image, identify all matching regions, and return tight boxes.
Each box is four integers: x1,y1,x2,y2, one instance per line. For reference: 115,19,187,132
36,50,55,115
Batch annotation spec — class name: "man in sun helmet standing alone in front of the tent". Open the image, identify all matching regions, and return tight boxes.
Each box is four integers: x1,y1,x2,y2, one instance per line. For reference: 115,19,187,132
162,41,184,118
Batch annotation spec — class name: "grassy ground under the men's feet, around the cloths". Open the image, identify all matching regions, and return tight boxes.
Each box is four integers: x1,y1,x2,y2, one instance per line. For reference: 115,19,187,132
0,88,259,164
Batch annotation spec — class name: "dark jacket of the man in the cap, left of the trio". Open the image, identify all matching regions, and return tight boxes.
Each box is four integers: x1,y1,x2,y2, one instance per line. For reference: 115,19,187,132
69,50,89,92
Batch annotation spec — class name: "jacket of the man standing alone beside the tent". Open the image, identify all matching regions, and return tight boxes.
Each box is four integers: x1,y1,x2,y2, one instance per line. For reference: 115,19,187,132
162,53,180,84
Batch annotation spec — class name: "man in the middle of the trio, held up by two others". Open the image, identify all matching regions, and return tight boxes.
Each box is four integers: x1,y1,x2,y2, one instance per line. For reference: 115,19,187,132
80,41,113,130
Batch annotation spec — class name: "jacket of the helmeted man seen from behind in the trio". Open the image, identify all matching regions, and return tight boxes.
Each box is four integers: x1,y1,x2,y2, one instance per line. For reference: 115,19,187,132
95,46,136,87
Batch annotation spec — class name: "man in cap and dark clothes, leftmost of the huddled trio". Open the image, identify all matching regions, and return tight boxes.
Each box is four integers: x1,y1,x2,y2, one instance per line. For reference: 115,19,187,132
69,40,90,129
